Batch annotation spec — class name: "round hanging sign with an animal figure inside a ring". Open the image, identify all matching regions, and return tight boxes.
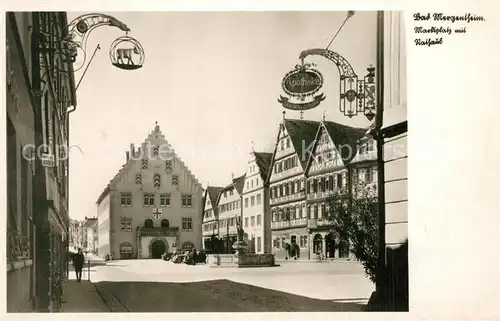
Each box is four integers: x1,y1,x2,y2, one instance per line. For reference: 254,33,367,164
109,36,145,70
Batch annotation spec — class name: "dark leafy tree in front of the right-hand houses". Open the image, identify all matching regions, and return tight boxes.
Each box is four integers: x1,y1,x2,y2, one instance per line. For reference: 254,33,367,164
328,183,379,283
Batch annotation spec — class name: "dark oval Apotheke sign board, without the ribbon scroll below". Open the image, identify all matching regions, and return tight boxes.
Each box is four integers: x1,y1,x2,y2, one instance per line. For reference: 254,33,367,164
282,66,323,97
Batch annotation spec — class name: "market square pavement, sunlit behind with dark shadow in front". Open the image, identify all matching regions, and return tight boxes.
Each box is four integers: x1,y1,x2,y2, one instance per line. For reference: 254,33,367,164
79,260,374,312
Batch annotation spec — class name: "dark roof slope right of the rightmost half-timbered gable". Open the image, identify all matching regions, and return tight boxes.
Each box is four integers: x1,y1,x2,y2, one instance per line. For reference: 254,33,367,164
322,121,367,164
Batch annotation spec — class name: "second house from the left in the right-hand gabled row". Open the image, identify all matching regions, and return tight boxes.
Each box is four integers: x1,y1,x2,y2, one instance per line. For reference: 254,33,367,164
217,175,245,253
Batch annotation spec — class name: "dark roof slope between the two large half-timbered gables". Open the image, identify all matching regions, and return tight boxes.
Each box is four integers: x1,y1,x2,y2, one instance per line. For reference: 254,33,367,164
284,119,320,170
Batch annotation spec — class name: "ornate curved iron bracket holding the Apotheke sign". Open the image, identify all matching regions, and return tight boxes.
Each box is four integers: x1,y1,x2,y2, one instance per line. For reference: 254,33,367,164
299,48,377,121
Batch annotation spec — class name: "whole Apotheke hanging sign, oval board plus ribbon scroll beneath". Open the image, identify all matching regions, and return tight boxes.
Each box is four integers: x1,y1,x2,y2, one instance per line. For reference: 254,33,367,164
278,63,325,111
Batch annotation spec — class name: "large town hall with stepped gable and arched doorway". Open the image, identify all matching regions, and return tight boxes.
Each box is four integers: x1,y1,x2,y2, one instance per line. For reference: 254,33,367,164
98,125,203,259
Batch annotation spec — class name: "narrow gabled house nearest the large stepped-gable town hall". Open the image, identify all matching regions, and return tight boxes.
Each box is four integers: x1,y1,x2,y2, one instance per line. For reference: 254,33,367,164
202,186,223,251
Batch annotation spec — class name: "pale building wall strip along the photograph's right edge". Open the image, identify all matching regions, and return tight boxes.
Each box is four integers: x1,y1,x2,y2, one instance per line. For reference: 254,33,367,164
382,11,409,311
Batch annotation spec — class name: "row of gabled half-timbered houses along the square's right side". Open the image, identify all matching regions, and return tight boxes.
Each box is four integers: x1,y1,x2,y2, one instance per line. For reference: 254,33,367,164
202,119,377,260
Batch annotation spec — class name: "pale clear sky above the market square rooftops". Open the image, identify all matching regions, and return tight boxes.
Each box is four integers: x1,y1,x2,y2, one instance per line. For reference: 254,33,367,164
68,11,402,219
